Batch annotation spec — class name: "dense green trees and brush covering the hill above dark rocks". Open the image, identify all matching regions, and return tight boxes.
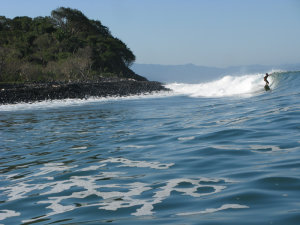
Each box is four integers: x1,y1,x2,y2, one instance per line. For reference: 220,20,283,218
0,7,143,82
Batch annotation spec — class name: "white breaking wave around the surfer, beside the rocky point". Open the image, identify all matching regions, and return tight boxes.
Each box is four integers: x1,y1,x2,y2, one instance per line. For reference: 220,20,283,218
166,71,293,97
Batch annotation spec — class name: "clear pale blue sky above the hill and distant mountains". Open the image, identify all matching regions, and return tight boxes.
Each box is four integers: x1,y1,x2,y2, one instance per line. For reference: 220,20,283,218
0,0,300,67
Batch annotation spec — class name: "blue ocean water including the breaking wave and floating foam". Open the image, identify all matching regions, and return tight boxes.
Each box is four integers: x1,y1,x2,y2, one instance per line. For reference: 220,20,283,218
0,72,300,225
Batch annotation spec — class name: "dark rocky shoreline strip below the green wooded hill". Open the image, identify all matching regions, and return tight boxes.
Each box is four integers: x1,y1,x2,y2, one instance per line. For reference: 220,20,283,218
0,79,168,104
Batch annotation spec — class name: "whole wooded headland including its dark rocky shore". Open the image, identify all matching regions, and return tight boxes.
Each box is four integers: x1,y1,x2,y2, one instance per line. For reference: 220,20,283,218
0,7,167,104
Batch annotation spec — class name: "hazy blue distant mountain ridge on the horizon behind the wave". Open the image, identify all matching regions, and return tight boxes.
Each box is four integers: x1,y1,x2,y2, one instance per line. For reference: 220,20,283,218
131,64,300,83
